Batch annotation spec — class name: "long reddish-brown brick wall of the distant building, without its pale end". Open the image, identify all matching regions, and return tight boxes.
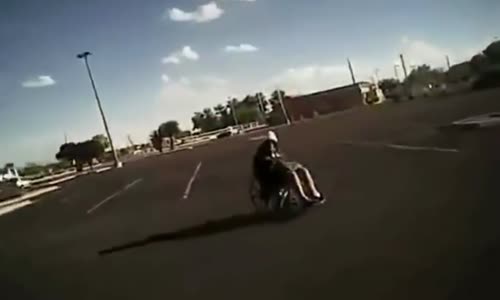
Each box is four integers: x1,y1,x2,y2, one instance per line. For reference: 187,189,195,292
284,85,363,121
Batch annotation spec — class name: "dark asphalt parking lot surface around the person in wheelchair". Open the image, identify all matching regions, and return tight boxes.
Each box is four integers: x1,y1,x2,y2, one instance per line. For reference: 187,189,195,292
0,90,500,300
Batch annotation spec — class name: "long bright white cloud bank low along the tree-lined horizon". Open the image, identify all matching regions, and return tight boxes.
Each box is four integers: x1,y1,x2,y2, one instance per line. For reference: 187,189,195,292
154,34,485,128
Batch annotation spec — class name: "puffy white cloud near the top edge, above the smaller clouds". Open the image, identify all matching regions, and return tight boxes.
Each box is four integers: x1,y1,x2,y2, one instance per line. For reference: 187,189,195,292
168,1,224,23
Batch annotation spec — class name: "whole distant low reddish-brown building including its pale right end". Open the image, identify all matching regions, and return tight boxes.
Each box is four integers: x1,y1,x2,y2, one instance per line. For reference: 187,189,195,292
284,82,385,121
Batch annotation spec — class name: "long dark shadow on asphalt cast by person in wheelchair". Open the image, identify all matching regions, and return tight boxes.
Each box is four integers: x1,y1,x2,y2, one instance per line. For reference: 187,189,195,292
98,213,298,256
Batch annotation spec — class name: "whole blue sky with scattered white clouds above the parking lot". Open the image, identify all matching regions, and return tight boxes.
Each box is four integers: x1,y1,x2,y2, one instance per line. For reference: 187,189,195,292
0,0,500,165
